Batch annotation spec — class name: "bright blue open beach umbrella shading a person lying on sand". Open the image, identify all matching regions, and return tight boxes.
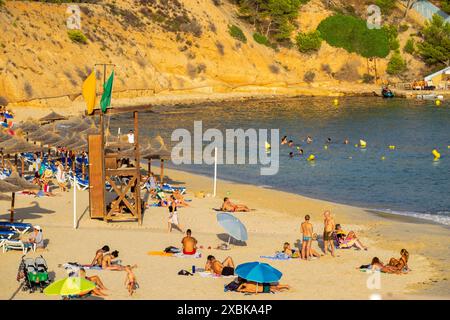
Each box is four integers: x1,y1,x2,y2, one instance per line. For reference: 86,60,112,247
236,262,283,283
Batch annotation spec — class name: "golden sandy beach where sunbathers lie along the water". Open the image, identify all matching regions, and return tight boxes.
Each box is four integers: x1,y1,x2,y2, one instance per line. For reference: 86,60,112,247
0,170,450,300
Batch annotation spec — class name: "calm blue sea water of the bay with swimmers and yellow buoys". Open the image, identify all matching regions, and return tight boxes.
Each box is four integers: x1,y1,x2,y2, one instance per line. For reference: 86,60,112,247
111,98,450,224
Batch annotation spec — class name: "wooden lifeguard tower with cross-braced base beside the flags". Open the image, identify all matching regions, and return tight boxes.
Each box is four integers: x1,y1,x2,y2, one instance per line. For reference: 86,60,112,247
88,105,150,225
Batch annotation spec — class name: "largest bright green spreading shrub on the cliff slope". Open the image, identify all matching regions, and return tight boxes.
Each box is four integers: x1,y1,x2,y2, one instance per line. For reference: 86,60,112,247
317,14,390,58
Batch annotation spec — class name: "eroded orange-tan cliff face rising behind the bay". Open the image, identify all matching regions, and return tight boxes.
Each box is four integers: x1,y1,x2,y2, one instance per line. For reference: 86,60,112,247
0,0,426,108
